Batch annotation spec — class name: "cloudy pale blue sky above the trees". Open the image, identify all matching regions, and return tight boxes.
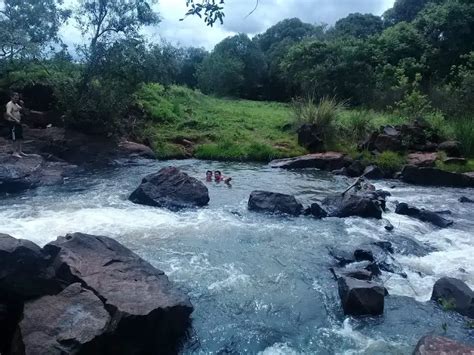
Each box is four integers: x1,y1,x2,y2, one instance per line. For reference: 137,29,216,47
61,0,394,50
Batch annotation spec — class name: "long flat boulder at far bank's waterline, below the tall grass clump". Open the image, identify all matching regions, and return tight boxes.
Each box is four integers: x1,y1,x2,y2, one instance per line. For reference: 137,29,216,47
270,152,352,171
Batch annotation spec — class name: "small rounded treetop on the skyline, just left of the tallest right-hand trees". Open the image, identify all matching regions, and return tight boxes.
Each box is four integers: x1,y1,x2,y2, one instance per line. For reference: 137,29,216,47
332,13,384,38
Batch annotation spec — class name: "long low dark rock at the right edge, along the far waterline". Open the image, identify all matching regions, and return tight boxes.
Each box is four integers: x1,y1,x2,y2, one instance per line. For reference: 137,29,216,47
401,165,474,187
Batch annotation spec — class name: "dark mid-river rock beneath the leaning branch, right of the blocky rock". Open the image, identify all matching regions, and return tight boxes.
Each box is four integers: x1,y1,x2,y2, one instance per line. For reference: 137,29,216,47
323,193,383,219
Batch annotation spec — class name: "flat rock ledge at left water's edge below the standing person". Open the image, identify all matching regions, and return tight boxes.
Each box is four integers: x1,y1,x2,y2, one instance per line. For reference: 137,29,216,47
0,154,76,193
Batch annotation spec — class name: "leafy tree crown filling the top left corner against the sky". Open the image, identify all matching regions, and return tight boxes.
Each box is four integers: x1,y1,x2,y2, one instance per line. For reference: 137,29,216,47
0,0,70,61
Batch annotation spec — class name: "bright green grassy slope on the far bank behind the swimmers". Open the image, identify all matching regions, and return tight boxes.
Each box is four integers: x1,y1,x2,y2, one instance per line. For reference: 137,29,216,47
135,84,305,161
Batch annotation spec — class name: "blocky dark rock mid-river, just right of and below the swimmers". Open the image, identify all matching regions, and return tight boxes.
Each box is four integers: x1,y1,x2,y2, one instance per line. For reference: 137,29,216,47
248,191,303,216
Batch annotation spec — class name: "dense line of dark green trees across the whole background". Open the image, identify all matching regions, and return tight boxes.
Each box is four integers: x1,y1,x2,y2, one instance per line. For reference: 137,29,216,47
0,0,474,135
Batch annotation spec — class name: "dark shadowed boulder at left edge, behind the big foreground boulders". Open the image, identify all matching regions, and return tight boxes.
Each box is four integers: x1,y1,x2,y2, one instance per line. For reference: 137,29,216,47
0,234,63,301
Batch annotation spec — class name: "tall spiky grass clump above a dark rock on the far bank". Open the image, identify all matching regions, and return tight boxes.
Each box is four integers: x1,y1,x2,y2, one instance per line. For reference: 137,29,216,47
291,97,345,144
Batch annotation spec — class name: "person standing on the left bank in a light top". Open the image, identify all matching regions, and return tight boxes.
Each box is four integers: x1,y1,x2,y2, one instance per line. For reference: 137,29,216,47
5,92,43,159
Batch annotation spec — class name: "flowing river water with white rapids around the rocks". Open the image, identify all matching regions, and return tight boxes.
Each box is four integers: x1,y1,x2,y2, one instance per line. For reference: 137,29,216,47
0,160,474,354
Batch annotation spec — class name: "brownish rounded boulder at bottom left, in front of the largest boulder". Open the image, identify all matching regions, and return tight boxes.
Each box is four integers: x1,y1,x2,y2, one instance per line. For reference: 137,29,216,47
12,283,111,355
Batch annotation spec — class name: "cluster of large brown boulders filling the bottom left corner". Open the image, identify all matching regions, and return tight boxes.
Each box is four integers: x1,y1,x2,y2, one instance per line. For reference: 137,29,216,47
0,233,193,355
